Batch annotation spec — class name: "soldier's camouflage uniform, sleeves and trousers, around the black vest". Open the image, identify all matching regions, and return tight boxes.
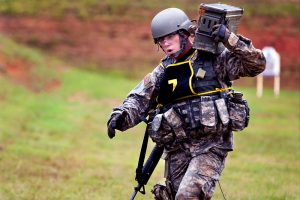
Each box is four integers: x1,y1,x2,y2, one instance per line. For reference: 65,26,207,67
112,35,265,199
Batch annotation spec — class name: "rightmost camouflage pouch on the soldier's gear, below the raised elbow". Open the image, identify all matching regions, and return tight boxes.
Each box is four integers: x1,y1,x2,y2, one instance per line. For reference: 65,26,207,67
228,93,250,131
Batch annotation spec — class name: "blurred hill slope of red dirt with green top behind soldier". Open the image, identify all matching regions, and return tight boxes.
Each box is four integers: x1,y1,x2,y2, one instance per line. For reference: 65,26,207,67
0,0,300,90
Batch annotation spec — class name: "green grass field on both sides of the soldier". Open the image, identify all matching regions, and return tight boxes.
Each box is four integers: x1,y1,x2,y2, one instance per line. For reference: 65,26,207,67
0,34,300,200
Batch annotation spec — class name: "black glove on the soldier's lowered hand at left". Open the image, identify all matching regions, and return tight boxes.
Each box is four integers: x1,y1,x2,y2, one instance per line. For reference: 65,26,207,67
107,112,125,139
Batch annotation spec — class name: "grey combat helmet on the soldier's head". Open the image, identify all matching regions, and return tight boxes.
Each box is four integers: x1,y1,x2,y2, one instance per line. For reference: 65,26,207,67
151,8,192,42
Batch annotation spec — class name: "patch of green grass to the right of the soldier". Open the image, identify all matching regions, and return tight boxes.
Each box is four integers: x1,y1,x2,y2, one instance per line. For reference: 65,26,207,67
216,89,300,199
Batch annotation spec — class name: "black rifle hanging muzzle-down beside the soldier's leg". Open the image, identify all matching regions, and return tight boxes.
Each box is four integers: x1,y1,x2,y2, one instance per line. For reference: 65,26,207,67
130,145,164,200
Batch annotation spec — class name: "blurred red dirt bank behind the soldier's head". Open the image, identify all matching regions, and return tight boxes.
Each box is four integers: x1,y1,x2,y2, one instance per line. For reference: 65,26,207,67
0,16,300,90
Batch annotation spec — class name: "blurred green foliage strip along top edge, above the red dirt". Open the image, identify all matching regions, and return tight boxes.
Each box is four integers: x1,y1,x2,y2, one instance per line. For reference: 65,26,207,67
0,0,300,18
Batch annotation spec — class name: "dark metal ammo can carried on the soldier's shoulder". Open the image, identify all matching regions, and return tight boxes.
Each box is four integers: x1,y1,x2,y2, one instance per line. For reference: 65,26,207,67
193,3,244,54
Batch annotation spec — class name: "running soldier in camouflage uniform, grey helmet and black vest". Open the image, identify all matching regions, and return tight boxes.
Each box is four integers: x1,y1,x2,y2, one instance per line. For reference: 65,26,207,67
107,8,265,200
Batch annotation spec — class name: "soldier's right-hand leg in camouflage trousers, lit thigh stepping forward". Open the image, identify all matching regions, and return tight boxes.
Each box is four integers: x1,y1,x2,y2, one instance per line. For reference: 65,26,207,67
175,148,227,200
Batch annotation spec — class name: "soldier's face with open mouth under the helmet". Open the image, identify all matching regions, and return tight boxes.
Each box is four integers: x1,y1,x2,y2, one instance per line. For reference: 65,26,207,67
158,33,180,56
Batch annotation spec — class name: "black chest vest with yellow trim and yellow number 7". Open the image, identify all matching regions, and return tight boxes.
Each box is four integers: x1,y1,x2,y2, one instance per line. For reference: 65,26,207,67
157,49,221,105
